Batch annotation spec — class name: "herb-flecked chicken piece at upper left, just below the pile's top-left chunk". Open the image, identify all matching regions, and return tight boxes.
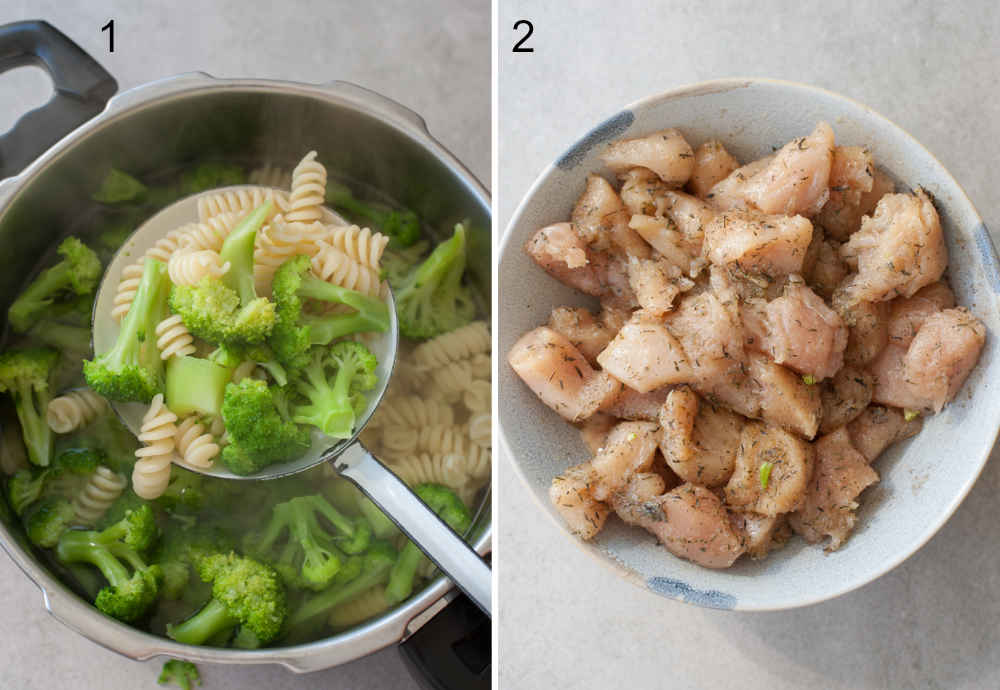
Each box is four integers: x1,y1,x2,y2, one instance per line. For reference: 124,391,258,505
570,175,650,258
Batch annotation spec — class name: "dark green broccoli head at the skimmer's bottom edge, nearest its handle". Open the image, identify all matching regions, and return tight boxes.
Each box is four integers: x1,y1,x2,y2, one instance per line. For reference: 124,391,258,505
222,379,310,475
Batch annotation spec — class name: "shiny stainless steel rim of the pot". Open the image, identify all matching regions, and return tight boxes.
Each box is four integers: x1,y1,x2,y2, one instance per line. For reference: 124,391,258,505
0,72,492,673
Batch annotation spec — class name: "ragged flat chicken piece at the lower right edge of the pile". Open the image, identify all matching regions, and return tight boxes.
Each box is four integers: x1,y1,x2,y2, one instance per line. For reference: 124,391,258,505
789,428,878,551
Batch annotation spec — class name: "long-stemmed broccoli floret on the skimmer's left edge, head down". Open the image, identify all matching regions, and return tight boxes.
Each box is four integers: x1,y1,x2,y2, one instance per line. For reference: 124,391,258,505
83,257,170,403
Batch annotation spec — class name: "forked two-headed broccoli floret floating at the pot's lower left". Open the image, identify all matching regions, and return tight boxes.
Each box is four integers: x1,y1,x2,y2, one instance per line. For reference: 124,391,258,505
56,505,163,623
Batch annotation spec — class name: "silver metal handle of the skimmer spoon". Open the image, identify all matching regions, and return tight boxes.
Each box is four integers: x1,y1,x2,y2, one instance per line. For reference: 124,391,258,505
331,443,492,616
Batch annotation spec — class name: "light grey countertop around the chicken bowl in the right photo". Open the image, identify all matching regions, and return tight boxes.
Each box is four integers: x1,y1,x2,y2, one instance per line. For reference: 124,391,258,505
504,0,1000,690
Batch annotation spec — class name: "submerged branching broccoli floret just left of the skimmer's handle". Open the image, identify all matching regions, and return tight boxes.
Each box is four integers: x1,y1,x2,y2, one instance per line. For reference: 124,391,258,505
244,495,371,590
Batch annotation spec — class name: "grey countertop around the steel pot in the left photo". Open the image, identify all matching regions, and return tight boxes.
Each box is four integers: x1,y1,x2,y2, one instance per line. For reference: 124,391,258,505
0,0,490,690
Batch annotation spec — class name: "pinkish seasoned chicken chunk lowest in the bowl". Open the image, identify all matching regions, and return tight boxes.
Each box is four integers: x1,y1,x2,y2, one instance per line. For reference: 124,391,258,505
639,484,744,568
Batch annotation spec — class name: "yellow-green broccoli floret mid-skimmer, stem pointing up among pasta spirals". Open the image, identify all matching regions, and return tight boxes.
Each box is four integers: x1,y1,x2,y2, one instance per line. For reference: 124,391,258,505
170,201,275,346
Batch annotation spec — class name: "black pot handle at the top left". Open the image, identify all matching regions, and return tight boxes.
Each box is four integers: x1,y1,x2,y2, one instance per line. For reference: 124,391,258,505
0,20,118,179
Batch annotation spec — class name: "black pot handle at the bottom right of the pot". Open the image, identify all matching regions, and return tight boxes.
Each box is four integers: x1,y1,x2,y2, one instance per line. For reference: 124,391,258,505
399,594,493,690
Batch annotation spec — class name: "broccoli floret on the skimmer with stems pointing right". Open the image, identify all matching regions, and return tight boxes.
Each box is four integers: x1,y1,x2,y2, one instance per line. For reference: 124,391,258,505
270,255,389,369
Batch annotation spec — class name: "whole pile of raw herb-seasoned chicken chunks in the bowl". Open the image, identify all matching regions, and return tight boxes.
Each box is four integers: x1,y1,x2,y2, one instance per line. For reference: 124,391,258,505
508,122,987,568
